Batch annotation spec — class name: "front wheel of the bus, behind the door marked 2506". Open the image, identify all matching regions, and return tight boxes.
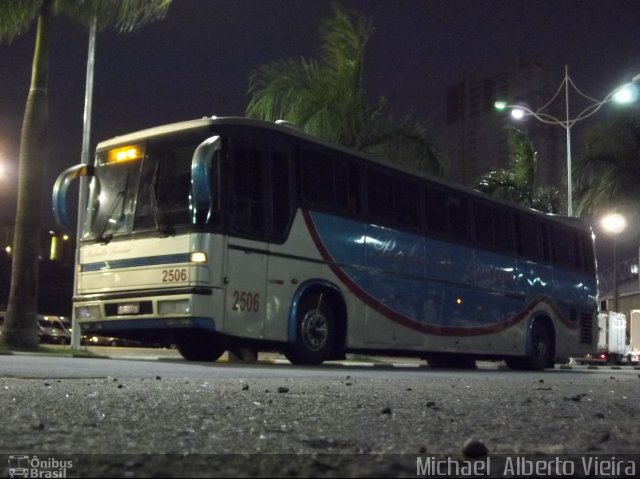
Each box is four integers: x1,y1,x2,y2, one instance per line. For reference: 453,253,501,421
284,294,336,365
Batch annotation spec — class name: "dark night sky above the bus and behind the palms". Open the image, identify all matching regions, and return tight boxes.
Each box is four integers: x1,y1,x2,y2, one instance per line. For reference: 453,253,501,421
0,0,640,232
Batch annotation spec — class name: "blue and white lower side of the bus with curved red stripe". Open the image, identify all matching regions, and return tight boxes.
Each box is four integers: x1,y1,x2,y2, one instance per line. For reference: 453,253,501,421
307,213,592,355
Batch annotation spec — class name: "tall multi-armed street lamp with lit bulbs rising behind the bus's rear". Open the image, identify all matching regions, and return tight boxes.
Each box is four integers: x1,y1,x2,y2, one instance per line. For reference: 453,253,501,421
495,65,640,216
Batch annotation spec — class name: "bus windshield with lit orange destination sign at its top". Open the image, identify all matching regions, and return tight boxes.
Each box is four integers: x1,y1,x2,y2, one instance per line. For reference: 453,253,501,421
83,130,214,243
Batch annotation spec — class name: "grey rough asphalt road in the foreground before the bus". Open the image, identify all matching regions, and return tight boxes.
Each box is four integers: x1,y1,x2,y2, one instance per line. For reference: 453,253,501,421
0,355,640,477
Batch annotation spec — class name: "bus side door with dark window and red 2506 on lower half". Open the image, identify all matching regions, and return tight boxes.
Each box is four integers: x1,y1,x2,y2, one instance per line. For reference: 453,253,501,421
223,140,269,338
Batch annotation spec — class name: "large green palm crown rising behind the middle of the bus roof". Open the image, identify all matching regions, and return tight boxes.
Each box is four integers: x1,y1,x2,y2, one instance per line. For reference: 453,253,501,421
247,5,444,176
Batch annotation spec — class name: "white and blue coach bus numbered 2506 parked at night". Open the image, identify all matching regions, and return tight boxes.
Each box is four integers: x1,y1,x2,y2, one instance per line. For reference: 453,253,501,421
53,117,597,369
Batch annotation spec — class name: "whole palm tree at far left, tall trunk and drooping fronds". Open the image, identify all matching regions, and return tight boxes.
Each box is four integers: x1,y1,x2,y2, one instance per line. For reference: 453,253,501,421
0,0,170,349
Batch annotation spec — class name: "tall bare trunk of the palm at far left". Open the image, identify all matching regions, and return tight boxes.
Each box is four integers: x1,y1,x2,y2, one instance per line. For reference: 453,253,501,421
3,0,51,349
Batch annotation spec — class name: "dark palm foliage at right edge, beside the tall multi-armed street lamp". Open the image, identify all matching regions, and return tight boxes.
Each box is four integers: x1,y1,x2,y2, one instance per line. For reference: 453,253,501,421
574,112,640,216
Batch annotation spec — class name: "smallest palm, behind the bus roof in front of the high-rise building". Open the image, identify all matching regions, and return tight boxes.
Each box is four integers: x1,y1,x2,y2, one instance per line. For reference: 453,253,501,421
475,126,562,213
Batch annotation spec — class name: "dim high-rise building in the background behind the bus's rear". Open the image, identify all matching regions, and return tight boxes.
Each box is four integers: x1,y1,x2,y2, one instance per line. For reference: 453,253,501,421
445,61,566,191
